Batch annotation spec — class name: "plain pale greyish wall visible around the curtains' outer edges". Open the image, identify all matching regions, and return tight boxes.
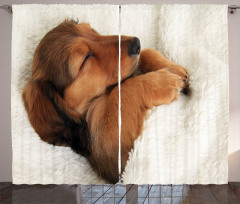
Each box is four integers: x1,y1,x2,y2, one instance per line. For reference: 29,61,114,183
0,0,240,182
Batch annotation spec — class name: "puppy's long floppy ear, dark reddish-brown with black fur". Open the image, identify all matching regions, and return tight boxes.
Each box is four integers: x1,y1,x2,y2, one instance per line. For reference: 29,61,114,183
22,80,89,156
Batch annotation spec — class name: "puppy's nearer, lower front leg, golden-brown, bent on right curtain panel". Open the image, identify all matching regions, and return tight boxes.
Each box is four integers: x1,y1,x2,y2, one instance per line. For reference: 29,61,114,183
121,68,184,140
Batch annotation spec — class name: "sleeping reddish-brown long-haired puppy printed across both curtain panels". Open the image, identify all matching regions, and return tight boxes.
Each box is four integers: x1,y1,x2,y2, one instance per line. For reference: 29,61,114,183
22,20,188,183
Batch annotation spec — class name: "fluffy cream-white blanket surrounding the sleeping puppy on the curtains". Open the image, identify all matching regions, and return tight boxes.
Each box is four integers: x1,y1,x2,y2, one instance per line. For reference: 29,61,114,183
12,5,228,184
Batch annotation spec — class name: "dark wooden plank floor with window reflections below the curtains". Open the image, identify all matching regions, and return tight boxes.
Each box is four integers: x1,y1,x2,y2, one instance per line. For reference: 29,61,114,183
0,183,240,204
